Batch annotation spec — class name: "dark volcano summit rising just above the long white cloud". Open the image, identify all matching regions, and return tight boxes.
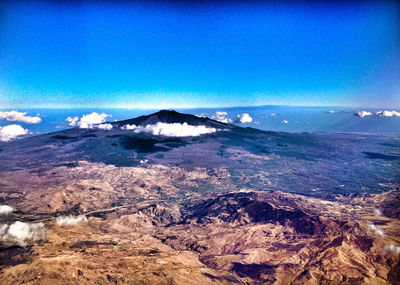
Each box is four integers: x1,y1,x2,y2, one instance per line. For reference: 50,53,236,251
112,110,234,129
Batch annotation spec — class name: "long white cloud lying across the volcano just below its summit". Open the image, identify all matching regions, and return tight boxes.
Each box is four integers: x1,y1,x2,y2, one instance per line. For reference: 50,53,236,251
134,122,217,137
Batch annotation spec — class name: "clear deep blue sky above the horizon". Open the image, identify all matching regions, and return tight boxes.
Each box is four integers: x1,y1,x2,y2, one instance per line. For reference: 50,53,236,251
0,1,400,108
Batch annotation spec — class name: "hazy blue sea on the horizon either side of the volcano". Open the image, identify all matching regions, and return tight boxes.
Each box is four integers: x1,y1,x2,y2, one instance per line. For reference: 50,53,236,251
0,106,400,134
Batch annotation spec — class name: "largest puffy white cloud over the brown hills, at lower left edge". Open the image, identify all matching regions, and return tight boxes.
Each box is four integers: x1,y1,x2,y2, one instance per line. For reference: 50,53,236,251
0,221,47,246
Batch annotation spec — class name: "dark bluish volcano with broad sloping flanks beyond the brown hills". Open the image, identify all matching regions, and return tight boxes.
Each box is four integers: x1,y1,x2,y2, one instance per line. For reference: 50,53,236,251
0,110,400,199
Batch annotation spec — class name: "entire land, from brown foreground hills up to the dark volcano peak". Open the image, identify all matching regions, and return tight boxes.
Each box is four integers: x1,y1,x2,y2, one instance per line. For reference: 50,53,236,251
0,111,400,284
